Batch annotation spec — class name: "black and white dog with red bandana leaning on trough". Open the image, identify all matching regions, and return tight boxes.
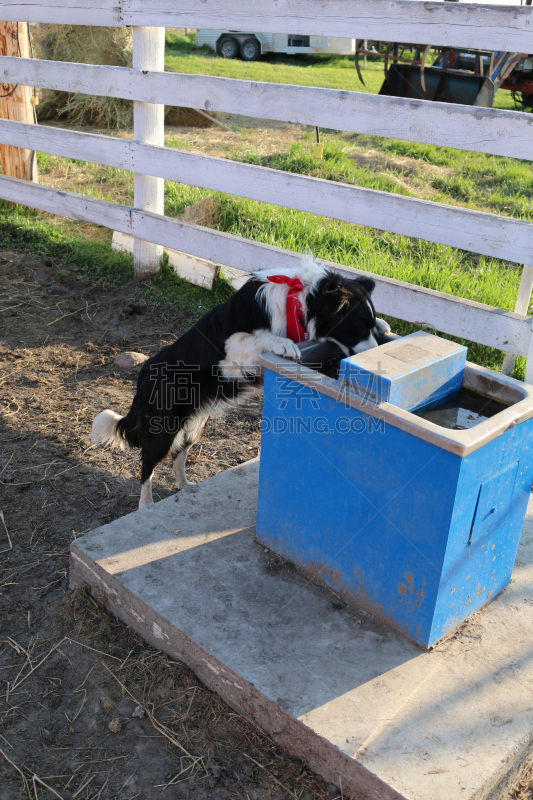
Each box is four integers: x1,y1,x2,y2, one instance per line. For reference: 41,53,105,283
92,258,388,508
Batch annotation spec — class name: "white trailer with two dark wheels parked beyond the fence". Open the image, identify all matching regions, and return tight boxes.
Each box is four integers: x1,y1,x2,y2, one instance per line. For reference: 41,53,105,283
196,29,355,61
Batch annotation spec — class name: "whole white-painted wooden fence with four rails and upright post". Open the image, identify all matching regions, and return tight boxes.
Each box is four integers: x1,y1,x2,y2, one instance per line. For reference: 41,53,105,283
0,0,533,382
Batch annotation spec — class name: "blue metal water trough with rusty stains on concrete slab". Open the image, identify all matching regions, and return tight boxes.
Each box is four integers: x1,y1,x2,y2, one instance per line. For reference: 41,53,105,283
257,332,533,648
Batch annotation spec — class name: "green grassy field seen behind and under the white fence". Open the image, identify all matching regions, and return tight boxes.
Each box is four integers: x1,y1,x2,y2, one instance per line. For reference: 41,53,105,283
0,33,533,376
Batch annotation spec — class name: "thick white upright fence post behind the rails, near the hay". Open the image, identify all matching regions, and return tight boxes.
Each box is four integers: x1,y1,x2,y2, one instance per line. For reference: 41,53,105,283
133,26,165,280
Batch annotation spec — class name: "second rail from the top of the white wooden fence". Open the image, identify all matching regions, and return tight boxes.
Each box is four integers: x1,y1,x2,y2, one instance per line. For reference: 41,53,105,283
0,57,533,160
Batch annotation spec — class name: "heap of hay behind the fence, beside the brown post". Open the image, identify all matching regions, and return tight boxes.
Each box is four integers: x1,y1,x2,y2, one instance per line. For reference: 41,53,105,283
32,24,216,129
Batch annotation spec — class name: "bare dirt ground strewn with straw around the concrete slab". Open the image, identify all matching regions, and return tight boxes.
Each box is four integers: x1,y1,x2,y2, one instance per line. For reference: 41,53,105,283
0,251,340,800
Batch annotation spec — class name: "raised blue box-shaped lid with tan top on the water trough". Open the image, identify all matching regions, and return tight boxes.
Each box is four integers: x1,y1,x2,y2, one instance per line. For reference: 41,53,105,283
339,331,467,411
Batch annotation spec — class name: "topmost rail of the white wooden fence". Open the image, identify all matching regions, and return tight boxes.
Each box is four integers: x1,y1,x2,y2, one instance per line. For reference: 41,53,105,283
0,0,533,52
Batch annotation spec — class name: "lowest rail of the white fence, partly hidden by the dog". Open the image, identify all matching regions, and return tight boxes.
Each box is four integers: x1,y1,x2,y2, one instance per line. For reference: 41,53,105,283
0,176,531,355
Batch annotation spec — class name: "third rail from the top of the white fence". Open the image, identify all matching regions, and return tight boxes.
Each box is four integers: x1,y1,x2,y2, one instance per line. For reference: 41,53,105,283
0,120,533,264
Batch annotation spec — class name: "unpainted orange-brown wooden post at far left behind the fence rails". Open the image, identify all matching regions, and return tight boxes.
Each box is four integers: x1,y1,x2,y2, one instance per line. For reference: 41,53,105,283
0,22,37,183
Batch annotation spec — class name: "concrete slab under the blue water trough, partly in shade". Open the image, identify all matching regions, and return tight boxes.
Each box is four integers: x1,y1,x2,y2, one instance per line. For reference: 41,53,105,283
71,460,533,800
